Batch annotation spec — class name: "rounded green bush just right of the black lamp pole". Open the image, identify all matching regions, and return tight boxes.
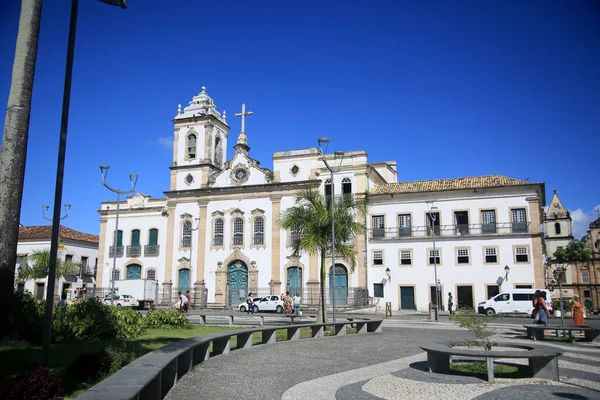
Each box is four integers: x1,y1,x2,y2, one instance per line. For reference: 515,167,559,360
53,299,118,341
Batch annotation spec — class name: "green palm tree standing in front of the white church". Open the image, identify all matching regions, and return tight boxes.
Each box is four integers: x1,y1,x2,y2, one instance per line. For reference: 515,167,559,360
279,189,366,322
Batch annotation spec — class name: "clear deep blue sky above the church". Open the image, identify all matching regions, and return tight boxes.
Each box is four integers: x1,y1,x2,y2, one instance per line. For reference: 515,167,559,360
0,0,600,239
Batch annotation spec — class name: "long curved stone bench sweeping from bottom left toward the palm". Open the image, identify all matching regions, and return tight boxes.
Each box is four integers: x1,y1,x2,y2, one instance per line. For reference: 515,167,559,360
77,319,383,400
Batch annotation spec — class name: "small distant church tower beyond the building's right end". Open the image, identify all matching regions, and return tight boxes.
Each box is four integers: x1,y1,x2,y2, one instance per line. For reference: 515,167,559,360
544,189,573,257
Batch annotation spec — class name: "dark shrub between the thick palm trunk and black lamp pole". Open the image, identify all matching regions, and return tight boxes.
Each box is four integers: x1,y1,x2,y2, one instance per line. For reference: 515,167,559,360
14,290,46,344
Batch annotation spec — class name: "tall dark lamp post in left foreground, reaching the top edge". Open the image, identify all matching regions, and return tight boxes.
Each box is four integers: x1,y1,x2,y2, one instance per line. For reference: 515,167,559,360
42,0,127,366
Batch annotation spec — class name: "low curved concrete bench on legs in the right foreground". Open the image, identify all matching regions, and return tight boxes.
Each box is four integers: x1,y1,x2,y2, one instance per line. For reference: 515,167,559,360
420,342,564,382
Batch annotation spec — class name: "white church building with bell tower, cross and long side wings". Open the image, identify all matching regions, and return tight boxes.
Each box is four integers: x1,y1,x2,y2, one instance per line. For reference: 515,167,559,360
97,88,545,310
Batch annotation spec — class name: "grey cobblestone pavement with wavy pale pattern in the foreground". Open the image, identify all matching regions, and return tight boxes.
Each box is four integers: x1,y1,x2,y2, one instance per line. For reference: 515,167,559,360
167,319,600,400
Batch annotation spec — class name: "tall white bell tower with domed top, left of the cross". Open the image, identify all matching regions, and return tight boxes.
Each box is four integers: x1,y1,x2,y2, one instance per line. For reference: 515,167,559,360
170,86,230,191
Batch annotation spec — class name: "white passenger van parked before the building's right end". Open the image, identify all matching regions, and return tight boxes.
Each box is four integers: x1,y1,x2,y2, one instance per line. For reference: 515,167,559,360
477,289,552,315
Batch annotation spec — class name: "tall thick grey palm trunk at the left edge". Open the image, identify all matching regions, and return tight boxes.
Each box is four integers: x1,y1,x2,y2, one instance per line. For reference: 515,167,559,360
0,0,42,337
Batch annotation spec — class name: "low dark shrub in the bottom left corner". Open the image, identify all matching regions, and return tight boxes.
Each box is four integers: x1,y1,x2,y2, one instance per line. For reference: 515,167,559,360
6,365,61,400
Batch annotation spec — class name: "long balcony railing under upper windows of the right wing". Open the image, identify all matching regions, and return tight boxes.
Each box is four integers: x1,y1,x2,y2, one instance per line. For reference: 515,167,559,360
369,222,530,239
